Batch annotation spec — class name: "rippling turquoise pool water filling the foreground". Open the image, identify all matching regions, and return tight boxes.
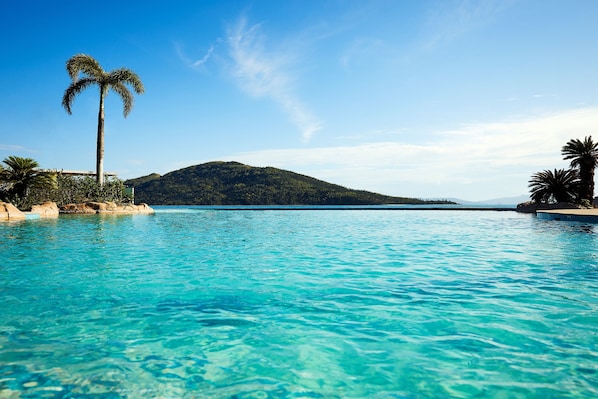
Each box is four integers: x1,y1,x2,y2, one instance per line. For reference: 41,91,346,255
0,207,598,399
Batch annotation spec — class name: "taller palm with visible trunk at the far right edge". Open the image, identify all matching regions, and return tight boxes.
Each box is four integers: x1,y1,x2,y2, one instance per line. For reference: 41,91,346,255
561,136,598,203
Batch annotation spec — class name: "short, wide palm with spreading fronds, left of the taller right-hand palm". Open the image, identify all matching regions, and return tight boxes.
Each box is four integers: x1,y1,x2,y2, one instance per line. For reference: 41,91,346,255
529,169,579,204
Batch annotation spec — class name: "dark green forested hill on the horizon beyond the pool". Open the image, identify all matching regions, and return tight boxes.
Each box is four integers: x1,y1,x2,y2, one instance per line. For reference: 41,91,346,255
125,162,449,205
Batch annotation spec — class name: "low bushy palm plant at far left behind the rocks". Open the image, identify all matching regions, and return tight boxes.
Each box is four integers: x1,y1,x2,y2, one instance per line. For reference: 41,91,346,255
1,156,56,208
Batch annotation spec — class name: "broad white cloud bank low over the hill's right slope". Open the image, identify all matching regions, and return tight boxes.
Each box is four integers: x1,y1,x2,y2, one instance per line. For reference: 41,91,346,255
218,108,598,200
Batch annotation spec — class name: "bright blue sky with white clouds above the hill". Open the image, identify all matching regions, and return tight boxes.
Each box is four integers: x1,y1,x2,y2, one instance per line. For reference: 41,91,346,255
0,0,598,200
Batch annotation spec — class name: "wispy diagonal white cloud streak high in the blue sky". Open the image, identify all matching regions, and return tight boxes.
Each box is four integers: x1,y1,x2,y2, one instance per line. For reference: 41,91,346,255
227,18,322,141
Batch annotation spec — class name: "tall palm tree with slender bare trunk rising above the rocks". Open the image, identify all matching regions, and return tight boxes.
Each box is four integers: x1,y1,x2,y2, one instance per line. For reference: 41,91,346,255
62,54,144,185
